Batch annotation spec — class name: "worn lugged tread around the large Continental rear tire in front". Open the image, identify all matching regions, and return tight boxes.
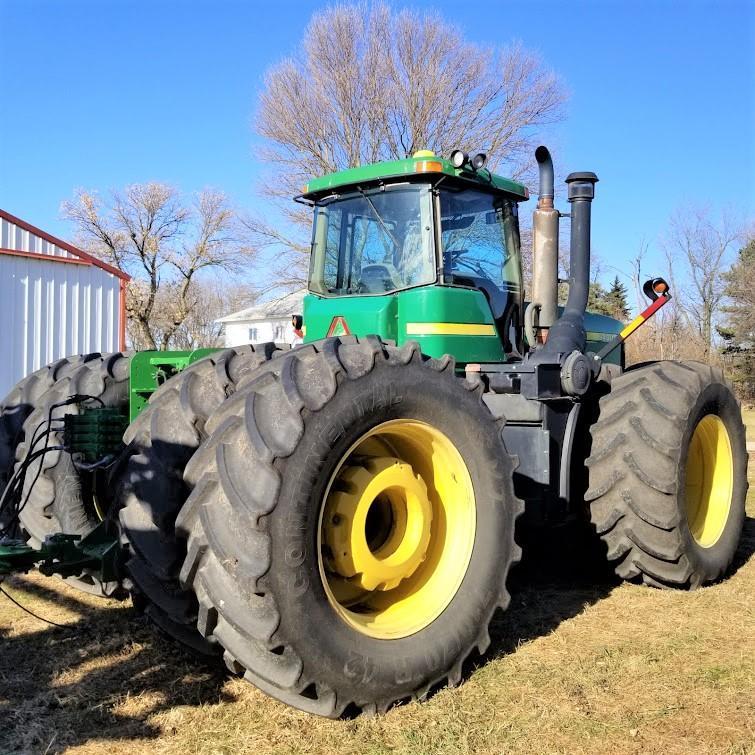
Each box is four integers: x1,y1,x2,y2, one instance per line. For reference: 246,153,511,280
176,337,523,717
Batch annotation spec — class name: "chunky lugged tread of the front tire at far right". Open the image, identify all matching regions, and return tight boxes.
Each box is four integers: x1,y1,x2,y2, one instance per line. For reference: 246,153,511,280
585,361,746,588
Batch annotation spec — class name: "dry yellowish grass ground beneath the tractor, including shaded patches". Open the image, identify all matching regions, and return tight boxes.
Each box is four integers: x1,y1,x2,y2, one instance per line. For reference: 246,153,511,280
0,434,755,755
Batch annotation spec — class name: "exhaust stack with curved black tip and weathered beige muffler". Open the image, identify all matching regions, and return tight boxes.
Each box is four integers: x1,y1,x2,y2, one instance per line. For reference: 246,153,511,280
530,147,559,345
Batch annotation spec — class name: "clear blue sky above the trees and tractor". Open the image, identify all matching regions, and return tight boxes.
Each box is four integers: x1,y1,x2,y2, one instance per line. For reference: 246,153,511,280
0,0,755,290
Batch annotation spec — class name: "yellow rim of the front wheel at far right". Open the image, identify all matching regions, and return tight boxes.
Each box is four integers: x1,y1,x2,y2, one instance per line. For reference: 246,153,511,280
685,414,734,548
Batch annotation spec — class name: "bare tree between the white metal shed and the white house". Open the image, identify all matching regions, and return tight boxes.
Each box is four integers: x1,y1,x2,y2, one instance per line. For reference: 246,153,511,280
62,183,253,350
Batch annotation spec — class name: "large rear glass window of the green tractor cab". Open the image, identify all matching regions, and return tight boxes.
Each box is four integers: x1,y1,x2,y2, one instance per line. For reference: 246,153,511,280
309,184,436,296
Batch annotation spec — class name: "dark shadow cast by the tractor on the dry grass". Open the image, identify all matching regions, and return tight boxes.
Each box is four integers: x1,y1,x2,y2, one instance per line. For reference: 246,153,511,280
0,510,755,753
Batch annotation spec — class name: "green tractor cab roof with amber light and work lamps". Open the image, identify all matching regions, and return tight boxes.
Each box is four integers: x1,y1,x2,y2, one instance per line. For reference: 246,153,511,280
301,150,530,201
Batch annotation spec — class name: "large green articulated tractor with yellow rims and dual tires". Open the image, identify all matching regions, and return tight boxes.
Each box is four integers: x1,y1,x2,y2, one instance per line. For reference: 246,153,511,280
0,147,747,717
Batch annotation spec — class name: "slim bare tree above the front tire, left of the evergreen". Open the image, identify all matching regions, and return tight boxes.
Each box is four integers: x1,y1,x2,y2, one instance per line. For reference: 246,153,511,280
663,208,741,361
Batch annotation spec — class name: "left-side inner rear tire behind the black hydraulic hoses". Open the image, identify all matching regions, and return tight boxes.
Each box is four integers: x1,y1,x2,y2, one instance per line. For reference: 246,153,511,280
16,353,129,596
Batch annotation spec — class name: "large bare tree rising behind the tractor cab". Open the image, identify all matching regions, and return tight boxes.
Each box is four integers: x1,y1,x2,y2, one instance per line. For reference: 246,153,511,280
251,3,565,287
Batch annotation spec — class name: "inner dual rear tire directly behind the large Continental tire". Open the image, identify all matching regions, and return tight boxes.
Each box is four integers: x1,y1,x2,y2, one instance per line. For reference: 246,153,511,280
116,343,276,655
